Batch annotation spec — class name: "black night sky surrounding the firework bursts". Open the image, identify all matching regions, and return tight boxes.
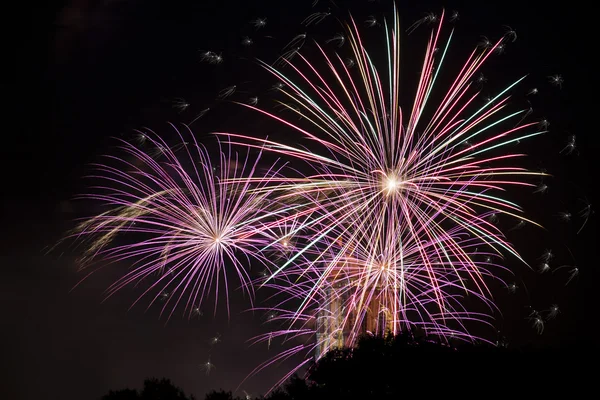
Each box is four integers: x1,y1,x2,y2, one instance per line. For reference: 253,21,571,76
0,0,598,400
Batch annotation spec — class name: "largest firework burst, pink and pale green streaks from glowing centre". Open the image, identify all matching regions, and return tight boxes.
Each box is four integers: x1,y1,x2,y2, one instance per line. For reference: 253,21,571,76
223,3,543,344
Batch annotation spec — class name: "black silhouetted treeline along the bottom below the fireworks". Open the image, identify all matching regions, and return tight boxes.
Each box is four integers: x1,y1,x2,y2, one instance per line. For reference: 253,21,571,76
102,334,597,400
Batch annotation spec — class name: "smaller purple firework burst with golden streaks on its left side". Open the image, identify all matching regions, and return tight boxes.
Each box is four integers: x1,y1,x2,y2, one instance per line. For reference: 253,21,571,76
68,125,284,316
